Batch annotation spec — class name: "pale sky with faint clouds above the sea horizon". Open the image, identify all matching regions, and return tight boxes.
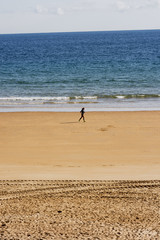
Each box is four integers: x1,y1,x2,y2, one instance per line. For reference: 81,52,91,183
0,0,160,34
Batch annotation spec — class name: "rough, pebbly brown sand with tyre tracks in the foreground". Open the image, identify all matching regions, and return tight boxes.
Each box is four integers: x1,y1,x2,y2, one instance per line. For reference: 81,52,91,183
0,180,160,240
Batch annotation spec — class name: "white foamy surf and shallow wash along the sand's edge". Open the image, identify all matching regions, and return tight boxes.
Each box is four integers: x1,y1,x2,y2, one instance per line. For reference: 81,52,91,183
0,97,160,112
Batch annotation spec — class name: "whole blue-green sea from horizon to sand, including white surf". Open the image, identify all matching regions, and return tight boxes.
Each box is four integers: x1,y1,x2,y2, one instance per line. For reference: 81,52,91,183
0,30,160,111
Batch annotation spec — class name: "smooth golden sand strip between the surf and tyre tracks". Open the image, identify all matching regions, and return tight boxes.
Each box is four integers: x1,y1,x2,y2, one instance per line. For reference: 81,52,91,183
0,111,160,180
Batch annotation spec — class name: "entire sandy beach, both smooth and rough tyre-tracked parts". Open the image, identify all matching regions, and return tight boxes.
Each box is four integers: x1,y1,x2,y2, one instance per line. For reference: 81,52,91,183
0,112,160,240
